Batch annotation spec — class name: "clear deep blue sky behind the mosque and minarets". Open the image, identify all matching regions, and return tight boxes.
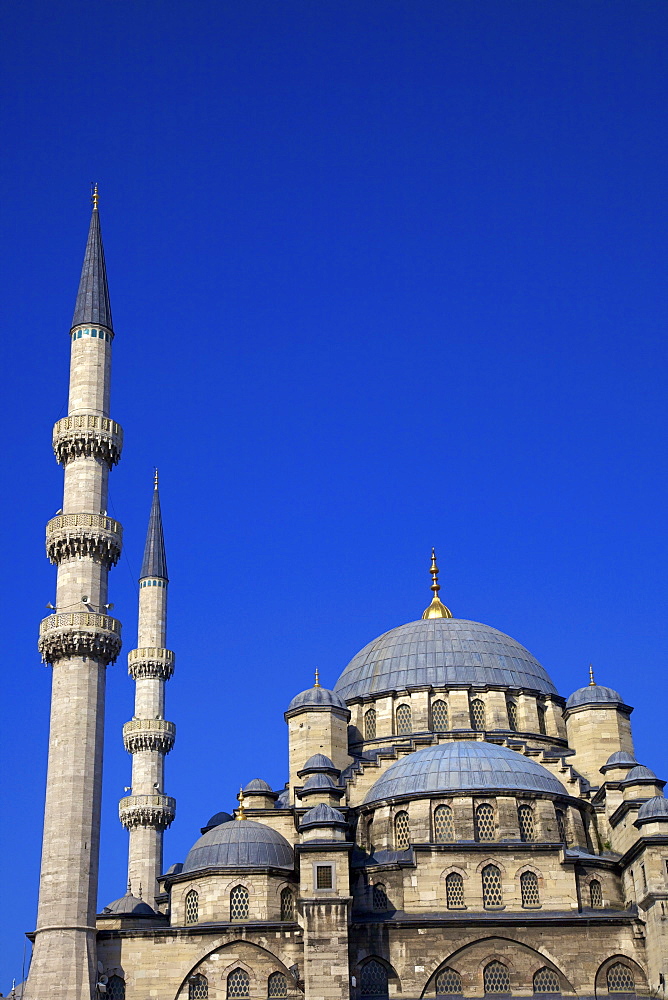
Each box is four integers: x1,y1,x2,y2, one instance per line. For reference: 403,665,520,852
0,0,668,991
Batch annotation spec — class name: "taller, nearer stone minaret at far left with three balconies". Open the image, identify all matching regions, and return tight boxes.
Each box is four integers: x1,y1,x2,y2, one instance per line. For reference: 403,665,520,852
26,187,123,1000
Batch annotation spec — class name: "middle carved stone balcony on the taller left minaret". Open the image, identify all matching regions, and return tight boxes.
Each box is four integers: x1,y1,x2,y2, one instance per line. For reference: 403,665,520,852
46,514,123,567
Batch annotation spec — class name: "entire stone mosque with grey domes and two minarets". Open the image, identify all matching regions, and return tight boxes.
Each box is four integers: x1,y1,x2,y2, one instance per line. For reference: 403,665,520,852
25,192,668,1000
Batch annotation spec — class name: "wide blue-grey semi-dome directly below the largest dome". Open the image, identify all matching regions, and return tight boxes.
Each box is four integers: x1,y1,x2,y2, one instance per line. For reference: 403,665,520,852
364,740,568,804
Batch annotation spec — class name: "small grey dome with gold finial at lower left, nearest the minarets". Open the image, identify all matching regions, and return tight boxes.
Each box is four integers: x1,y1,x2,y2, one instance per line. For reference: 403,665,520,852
183,819,294,872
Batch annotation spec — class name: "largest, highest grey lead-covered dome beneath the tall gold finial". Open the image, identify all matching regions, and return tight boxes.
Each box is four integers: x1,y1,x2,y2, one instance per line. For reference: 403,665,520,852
334,618,557,701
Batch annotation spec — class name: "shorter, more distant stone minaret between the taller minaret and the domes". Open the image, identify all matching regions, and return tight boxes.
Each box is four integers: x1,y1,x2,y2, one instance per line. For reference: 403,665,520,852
119,470,176,906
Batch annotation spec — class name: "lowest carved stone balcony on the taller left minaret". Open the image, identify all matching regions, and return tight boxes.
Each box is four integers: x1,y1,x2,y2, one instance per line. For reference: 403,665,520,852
38,611,121,664
